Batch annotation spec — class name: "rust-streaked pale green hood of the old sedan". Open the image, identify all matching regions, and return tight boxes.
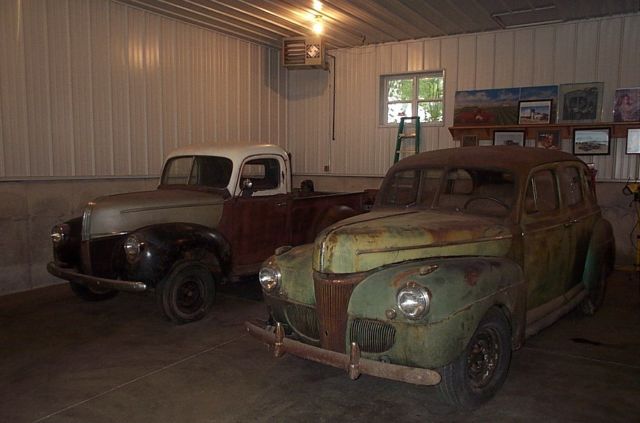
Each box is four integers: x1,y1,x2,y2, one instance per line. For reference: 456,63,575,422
313,209,511,274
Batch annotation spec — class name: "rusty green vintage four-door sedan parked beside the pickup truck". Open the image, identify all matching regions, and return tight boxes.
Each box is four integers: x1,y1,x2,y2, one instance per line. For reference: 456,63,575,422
246,146,614,409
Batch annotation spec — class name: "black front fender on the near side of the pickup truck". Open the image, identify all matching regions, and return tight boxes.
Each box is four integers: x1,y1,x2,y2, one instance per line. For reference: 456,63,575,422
116,223,231,286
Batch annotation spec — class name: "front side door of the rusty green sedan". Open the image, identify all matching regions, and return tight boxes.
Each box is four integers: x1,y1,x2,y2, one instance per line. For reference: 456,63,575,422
521,165,573,310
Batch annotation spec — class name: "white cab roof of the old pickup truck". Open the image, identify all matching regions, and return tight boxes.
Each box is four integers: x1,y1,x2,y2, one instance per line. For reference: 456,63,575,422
167,143,287,161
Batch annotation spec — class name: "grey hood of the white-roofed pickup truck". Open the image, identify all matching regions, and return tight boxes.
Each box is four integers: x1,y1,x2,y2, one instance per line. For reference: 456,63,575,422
83,189,224,239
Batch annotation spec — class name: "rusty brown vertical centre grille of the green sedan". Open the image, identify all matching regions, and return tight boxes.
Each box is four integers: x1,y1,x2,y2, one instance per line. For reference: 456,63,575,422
313,273,366,353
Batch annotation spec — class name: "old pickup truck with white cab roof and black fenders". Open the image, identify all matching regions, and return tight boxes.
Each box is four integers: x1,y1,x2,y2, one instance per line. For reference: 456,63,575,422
48,145,375,323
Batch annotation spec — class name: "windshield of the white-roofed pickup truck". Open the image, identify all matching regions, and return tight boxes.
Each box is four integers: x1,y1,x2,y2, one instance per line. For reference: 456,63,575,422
162,156,233,189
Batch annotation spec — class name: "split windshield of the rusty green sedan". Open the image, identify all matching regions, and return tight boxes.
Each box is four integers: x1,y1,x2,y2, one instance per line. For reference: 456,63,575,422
380,167,515,216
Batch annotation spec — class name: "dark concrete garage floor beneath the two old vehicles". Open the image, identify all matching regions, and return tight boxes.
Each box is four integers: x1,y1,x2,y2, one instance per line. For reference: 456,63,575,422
0,272,640,423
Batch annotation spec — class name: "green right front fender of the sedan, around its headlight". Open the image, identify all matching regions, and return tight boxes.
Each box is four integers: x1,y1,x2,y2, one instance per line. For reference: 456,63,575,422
346,256,526,368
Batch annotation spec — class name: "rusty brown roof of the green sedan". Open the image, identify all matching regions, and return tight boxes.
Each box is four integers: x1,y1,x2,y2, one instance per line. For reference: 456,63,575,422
390,145,584,173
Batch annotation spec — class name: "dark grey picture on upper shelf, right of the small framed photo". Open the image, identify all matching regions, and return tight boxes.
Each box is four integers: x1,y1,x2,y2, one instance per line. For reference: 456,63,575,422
560,82,604,122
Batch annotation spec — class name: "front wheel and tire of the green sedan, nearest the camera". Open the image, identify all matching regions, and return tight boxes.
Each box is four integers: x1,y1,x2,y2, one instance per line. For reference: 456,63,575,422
437,308,511,410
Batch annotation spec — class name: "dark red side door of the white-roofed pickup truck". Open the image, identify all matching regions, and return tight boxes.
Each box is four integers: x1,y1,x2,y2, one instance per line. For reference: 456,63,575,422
231,155,290,273
